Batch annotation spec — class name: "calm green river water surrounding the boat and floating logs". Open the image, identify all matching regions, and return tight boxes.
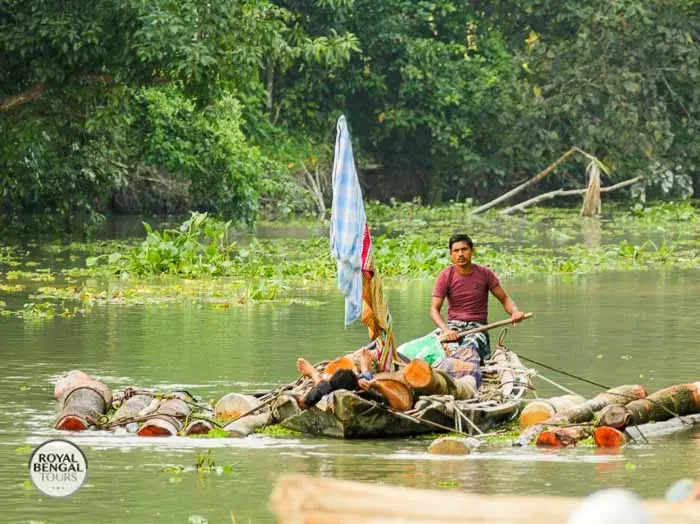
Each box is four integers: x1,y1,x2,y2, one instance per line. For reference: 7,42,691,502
0,271,700,523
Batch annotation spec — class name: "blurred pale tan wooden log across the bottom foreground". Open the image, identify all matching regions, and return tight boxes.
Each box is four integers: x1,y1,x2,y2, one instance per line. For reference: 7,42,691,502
271,474,700,524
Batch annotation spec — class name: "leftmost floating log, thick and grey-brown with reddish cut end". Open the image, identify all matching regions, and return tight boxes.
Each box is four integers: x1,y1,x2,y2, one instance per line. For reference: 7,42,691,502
54,370,112,431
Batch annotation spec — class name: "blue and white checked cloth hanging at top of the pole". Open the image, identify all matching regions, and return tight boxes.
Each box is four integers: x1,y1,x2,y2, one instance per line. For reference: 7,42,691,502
330,115,367,327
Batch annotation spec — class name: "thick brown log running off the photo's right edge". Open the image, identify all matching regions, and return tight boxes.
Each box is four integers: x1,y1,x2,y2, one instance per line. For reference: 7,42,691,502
625,382,700,424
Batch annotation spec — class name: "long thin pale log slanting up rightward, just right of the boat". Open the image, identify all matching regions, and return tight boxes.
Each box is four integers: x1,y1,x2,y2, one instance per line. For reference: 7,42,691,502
513,385,647,446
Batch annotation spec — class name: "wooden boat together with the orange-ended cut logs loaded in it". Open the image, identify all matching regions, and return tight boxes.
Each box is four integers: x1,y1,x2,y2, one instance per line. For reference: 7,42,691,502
282,347,533,438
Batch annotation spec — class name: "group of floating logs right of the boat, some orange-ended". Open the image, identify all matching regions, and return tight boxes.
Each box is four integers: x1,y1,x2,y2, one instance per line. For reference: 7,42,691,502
514,382,700,448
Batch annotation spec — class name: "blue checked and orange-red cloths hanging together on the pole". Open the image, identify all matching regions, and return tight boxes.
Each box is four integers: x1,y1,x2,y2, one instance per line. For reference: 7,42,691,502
330,116,395,371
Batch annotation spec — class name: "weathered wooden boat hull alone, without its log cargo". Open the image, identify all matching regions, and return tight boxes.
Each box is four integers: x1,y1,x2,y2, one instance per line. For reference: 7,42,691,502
281,346,534,438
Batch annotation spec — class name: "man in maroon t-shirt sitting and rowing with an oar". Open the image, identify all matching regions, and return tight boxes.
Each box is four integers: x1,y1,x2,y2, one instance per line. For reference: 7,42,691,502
430,234,524,387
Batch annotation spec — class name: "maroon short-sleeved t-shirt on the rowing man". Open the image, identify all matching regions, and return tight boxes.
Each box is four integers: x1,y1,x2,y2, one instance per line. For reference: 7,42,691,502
433,264,500,324
